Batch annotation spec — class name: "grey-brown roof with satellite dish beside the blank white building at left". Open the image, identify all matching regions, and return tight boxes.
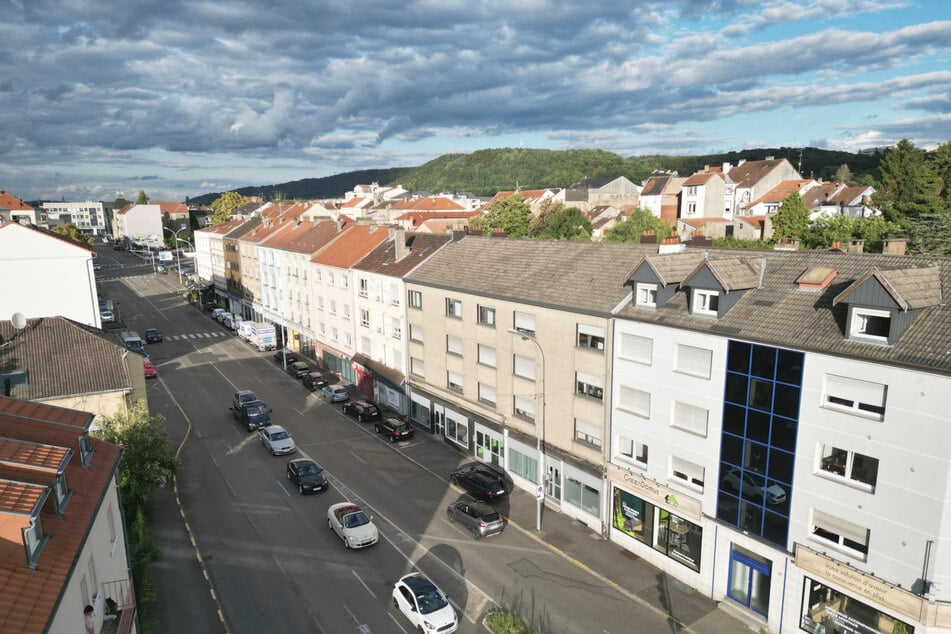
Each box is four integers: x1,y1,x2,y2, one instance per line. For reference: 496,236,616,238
0,317,132,400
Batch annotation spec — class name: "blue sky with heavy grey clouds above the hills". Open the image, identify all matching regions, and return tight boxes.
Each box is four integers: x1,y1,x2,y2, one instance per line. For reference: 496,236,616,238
0,0,951,200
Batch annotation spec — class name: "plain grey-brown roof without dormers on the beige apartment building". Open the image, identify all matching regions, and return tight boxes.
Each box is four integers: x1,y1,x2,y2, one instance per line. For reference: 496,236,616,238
405,235,657,316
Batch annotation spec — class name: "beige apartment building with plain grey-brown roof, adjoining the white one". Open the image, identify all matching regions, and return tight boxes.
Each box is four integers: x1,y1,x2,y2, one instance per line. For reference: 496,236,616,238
404,236,658,532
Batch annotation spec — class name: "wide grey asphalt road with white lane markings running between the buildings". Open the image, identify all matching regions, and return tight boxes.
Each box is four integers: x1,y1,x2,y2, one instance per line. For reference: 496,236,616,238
100,247,692,634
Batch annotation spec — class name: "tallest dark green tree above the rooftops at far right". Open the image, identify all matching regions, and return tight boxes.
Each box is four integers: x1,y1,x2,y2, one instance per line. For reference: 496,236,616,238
873,139,940,222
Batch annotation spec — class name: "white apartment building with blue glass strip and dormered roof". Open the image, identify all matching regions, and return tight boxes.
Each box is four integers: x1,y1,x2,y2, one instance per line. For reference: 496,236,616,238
607,247,951,632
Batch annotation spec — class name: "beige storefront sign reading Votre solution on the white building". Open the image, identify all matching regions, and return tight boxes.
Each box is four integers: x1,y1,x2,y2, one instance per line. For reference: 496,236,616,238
796,544,924,620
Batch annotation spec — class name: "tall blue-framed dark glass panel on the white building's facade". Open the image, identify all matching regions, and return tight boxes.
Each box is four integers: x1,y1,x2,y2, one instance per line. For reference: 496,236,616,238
717,341,803,549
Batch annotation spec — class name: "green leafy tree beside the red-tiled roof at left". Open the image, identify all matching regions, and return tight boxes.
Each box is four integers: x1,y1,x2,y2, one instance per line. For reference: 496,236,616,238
98,401,181,519
